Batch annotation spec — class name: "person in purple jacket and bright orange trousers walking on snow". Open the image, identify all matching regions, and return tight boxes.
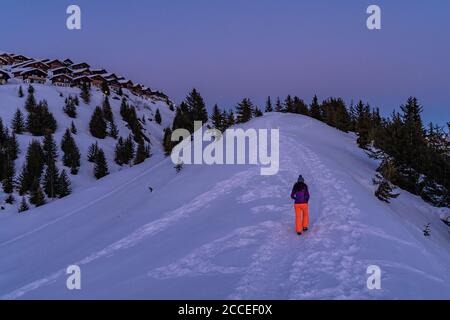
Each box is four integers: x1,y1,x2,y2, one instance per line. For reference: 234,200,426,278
291,175,309,235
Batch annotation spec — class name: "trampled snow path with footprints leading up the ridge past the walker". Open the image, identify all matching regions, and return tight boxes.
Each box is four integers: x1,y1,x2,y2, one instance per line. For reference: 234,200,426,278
230,132,365,299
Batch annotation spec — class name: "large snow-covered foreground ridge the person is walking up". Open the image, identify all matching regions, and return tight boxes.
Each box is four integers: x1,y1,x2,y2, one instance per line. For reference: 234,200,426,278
0,114,450,299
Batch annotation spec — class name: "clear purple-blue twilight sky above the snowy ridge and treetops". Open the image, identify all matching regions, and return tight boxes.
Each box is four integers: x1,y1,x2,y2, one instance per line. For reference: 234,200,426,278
0,0,450,124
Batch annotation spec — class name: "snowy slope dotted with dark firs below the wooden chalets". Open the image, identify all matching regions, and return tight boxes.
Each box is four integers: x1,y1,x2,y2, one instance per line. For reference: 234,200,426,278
0,80,174,212
